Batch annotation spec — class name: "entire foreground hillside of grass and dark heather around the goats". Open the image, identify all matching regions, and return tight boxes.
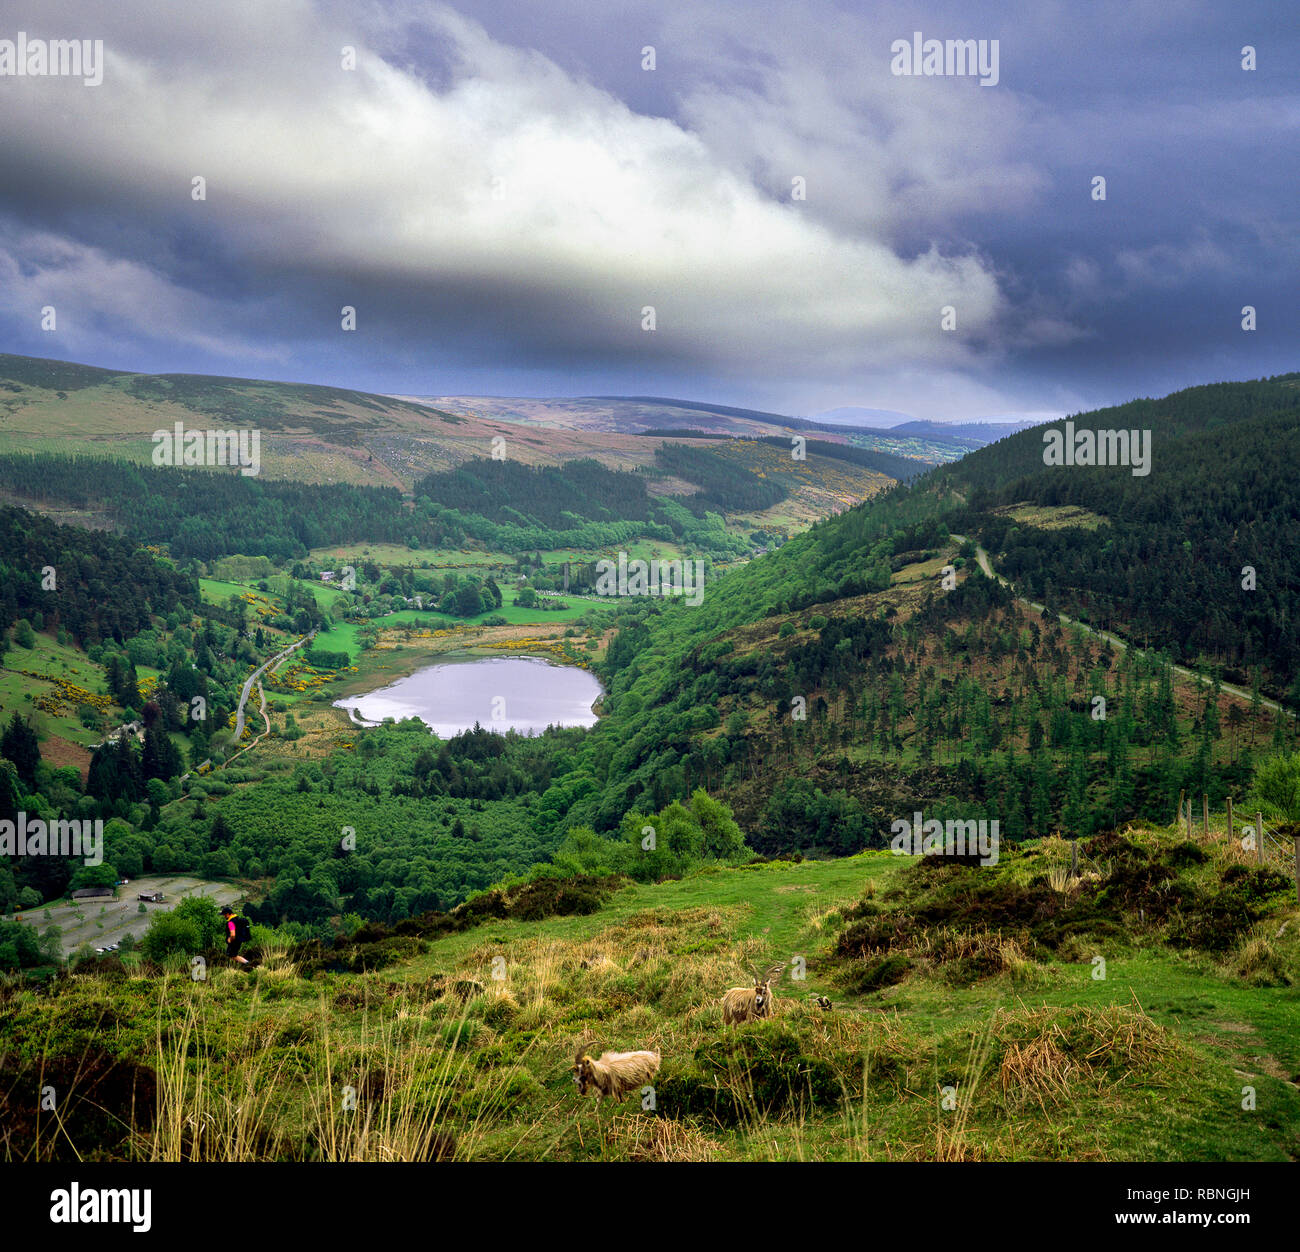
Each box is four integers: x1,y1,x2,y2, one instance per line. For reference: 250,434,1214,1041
0,823,1300,1161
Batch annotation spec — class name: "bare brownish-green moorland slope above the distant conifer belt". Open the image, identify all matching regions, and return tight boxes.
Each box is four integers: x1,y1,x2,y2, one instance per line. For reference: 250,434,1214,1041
0,352,894,514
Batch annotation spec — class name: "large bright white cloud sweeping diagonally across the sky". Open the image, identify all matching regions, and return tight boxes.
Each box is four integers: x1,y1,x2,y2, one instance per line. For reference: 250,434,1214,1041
0,0,1008,376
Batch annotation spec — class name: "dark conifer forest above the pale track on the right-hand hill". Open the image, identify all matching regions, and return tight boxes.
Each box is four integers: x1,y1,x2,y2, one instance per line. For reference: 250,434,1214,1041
926,374,1300,707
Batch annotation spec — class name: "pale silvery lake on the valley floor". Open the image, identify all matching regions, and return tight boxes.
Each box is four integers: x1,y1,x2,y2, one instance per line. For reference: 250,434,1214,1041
334,657,602,738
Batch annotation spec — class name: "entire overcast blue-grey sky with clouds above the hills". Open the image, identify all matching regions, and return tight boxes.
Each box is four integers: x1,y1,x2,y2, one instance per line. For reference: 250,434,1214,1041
0,0,1300,419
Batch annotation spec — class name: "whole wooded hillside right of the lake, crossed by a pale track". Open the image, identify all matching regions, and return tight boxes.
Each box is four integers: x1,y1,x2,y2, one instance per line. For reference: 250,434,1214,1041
512,380,1300,878
